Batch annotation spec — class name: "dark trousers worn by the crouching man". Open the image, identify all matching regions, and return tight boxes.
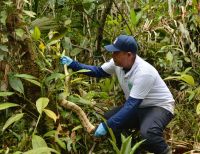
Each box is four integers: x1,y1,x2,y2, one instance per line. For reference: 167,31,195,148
104,107,173,154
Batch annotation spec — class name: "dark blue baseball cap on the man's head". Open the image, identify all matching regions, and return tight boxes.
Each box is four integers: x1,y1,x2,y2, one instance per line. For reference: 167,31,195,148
104,35,138,53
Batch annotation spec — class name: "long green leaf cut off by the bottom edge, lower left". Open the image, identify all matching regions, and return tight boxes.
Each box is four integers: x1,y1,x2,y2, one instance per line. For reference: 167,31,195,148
23,147,60,154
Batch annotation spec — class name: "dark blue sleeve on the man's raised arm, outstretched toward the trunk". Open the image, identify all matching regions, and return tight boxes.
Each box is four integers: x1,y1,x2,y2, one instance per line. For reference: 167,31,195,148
69,61,110,78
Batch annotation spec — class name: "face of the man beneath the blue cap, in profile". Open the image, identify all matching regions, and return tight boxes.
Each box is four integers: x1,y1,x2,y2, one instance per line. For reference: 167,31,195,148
112,51,133,69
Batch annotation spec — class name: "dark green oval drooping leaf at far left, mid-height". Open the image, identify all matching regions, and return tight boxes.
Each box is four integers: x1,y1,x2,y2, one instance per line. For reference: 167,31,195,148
9,76,24,94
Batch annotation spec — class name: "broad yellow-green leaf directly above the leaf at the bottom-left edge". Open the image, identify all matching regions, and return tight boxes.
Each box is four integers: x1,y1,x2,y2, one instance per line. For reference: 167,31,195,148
32,135,47,149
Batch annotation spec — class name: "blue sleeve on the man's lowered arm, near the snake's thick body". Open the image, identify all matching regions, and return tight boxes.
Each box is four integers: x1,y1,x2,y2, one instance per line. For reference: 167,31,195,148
107,96,142,130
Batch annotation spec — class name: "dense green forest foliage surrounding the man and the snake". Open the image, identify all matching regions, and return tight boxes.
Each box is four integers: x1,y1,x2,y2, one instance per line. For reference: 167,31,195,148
0,0,200,153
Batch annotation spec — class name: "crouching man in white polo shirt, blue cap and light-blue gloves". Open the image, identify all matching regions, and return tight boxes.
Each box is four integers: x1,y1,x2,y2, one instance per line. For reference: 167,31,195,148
61,35,174,154
